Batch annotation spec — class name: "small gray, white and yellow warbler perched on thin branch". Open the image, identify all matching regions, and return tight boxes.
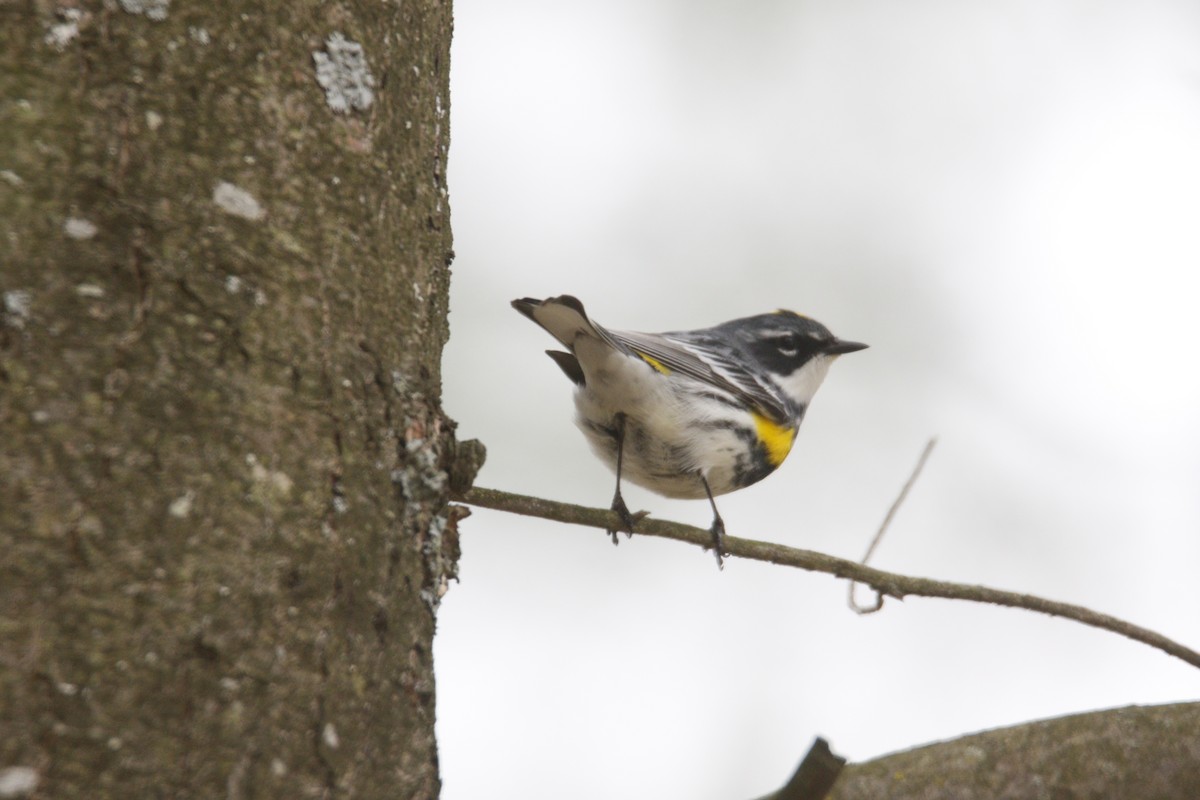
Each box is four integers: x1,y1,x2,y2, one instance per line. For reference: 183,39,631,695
512,295,866,564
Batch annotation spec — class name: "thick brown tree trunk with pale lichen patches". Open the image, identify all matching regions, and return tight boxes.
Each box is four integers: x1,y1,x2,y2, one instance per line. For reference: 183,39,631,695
0,0,456,799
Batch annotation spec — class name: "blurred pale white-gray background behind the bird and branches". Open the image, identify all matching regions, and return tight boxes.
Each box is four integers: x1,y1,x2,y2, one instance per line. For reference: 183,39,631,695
436,0,1200,800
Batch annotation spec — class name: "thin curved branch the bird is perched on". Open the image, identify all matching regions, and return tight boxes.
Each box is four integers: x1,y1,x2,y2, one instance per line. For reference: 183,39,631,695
455,487,1200,668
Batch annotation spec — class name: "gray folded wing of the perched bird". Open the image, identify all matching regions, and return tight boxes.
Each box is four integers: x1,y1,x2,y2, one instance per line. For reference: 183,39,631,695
604,330,790,423
